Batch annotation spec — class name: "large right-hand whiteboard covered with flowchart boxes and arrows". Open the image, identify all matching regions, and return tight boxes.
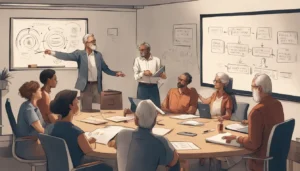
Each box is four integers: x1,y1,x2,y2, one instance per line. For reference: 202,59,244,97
200,11,300,101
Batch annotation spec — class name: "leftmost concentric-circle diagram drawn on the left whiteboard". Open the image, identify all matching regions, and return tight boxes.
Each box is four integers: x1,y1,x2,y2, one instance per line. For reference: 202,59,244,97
16,28,40,54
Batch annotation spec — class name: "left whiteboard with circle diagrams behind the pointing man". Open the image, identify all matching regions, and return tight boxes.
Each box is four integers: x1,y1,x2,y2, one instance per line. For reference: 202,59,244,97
10,18,88,70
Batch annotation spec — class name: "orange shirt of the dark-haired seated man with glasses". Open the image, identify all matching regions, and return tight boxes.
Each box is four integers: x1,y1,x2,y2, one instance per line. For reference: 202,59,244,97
162,88,198,114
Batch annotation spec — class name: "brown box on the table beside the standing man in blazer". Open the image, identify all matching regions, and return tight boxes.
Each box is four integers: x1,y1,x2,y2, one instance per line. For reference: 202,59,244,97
100,90,123,110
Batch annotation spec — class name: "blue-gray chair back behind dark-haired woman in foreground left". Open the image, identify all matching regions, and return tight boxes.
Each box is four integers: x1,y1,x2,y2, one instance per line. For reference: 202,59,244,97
38,134,74,171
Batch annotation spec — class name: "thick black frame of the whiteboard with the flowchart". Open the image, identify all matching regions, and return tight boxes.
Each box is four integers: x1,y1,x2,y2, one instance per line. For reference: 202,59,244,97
200,9,300,102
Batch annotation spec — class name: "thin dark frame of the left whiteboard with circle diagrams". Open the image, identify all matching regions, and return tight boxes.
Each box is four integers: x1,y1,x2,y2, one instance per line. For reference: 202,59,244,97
9,17,89,71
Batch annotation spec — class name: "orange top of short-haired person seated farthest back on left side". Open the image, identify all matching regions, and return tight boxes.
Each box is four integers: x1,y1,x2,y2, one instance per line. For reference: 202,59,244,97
37,89,51,123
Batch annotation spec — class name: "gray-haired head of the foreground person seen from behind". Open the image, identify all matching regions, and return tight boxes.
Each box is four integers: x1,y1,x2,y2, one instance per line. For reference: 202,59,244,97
135,100,157,129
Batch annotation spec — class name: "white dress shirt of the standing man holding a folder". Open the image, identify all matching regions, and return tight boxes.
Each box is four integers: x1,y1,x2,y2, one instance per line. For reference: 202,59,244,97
133,55,161,84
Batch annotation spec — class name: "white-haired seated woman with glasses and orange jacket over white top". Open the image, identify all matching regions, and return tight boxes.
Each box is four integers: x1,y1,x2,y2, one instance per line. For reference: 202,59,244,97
199,72,233,120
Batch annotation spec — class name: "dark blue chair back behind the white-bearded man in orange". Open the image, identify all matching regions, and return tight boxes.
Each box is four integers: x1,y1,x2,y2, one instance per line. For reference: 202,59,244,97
266,119,295,171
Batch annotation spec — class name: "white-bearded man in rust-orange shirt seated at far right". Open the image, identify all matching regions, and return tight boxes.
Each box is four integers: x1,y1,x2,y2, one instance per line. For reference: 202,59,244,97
223,74,284,171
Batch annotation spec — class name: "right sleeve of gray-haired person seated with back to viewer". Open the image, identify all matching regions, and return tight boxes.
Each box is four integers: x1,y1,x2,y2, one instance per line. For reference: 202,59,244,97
158,137,175,165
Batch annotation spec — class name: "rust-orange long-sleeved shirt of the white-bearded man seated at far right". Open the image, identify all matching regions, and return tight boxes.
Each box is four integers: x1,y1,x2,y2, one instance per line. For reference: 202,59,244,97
237,96,284,171
